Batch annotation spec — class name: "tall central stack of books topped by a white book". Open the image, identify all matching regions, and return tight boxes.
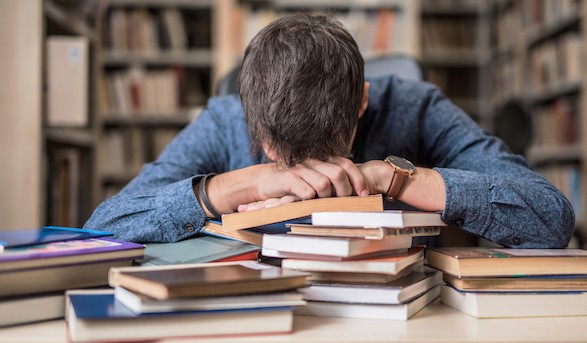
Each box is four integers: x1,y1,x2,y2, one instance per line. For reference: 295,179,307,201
262,211,445,320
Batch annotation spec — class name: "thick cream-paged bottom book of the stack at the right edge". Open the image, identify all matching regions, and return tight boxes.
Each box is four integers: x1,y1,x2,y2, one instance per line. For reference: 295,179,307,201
441,285,587,318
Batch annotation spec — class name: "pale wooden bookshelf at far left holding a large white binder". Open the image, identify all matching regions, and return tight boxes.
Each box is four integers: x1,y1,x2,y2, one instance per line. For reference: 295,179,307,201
0,0,95,229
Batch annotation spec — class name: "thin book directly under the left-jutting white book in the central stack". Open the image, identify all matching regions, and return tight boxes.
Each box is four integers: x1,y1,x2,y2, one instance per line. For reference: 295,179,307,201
281,246,424,275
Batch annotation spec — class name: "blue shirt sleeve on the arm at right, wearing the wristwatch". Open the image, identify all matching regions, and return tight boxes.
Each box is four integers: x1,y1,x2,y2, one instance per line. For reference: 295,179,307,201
423,88,575,248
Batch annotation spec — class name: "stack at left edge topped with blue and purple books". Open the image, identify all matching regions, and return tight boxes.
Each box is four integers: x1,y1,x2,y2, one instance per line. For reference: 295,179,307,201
0,227,144,327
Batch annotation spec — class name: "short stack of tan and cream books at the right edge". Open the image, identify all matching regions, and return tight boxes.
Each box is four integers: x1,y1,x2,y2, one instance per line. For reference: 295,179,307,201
426,247,587,318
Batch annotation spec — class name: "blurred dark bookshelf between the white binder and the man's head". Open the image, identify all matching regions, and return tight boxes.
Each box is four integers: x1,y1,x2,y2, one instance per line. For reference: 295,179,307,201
96,0,216,200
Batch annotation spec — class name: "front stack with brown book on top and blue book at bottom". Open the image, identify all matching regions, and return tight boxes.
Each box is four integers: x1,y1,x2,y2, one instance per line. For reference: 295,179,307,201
66,261,308,342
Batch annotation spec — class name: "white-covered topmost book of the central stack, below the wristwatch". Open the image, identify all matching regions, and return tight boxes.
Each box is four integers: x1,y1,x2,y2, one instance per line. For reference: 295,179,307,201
312,209,446,228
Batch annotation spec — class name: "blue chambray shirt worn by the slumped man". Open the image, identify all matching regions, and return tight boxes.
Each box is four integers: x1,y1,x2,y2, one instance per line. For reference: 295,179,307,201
85,76,574,248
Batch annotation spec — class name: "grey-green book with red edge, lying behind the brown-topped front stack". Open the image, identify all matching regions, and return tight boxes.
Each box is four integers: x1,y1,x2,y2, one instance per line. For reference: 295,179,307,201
139,235,261,266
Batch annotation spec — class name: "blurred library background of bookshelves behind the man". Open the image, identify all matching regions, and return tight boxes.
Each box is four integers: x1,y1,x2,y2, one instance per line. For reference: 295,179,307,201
0,0,587,246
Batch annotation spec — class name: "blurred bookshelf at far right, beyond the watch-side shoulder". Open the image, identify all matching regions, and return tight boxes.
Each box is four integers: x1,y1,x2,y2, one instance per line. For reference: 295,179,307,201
491,0,587,248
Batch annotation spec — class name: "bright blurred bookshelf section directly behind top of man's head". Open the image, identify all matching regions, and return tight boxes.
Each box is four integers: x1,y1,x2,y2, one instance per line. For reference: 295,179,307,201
215,0,421,84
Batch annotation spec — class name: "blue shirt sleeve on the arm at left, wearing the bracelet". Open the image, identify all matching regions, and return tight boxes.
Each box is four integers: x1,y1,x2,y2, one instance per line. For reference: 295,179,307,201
85,109,233,243
